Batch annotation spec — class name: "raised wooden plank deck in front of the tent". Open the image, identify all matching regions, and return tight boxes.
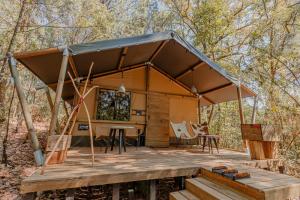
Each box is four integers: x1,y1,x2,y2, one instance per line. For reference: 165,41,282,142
21,147,300,199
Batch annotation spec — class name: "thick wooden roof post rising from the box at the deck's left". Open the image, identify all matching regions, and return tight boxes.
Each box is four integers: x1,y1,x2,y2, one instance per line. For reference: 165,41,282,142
49,47,69,135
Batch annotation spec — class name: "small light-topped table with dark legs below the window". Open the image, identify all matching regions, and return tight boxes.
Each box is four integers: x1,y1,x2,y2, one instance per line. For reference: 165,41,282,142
104,125,136,154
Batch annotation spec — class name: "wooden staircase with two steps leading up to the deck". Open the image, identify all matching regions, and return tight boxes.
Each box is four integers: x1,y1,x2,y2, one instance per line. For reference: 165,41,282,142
170,177,254,200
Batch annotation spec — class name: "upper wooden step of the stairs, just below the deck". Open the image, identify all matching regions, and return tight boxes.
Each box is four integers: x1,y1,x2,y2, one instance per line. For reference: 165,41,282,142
186,177,253,200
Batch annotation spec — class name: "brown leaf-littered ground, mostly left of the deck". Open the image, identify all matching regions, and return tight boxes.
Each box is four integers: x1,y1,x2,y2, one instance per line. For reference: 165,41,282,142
0,122,300,200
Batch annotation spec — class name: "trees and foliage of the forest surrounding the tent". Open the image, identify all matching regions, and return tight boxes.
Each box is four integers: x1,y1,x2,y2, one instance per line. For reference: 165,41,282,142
0,0,300,196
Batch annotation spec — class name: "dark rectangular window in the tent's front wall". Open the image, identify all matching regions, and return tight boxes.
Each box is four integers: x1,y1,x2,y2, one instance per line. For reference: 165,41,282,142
96,89,131,121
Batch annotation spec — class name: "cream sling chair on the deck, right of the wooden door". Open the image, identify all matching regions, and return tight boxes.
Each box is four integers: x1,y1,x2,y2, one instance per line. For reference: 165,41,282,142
170,121,198,145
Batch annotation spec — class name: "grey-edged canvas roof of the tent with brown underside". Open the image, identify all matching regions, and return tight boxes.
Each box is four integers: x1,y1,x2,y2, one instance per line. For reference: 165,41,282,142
14,31,255,105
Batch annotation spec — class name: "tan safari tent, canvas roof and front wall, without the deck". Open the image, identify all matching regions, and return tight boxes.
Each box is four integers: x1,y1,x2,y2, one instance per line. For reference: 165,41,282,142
14,32,255,147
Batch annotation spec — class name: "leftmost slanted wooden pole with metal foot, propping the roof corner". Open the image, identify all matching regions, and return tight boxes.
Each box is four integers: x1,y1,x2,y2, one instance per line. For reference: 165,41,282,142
7,53,44,166
